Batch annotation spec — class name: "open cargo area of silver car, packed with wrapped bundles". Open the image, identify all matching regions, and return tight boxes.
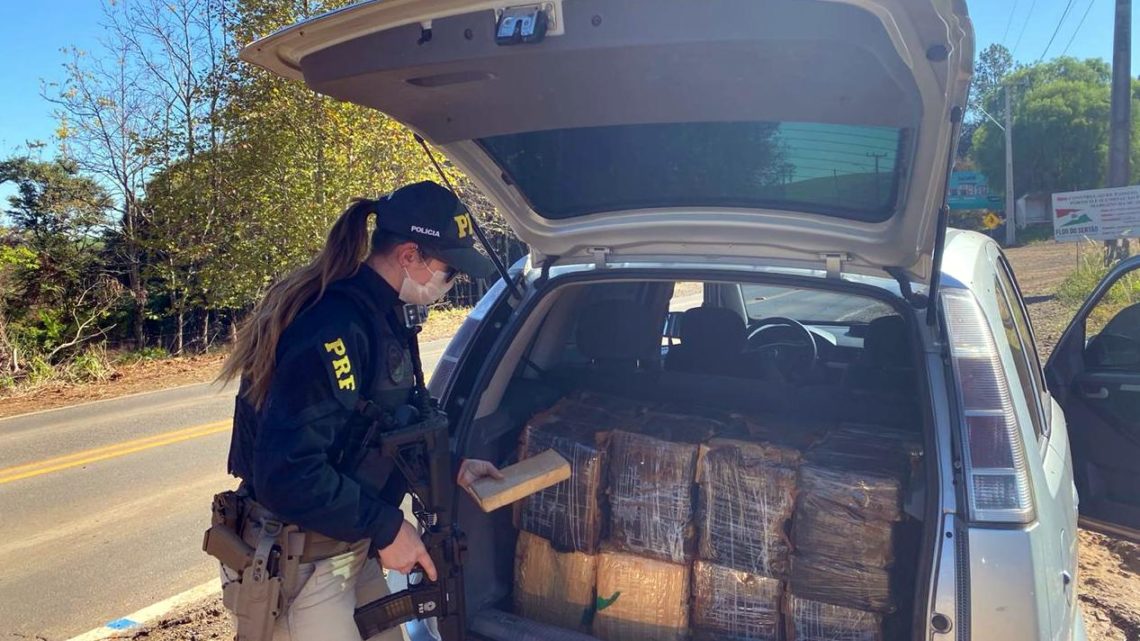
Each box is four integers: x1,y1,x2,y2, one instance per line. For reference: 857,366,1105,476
449,270,937,641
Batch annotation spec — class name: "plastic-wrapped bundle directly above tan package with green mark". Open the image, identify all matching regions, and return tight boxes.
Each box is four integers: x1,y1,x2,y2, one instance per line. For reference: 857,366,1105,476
609,430,697,562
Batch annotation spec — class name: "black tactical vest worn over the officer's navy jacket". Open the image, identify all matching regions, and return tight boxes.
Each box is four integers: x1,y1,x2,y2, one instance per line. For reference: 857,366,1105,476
229,269,415,503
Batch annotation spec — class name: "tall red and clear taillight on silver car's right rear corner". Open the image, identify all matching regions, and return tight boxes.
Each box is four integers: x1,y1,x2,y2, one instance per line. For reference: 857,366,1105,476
942,289,1035,524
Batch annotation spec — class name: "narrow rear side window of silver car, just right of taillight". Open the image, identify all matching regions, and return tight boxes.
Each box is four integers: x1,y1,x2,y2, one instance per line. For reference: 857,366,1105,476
995,260,1049,438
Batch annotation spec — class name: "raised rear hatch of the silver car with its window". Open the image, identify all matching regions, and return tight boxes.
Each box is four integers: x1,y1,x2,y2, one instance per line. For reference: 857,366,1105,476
242,0,974,285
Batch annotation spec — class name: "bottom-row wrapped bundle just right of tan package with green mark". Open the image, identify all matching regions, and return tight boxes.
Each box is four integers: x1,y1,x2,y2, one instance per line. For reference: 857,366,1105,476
692,561,783,641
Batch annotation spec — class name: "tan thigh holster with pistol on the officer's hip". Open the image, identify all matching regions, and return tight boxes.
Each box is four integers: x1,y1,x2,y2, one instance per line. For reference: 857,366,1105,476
202,492,304,641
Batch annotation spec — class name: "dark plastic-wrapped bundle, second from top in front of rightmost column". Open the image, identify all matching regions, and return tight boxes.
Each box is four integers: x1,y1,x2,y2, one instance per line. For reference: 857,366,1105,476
792,501,895,568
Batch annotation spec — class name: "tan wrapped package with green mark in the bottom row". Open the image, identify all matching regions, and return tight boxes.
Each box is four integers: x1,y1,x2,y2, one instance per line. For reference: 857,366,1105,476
594,550,690,641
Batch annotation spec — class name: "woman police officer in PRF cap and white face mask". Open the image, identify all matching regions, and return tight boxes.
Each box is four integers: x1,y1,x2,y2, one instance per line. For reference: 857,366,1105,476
221,181,502,641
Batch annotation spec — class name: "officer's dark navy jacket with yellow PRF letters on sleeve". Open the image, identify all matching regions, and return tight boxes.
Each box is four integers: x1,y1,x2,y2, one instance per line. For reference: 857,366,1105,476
229,266,413,549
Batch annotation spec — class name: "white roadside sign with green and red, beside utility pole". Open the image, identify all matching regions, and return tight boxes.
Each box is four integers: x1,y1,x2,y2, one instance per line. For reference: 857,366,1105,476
1053,185,1140,241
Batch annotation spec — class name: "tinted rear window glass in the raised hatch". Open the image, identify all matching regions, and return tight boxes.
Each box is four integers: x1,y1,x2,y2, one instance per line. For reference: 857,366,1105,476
479,122,906,221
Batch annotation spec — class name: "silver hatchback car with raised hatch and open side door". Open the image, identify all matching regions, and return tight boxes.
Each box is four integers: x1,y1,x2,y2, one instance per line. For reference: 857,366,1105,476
243,0,1140,641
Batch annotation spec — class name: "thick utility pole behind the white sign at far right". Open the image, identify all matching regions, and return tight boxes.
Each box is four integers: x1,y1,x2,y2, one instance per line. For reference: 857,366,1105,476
1105,0,1132,263
